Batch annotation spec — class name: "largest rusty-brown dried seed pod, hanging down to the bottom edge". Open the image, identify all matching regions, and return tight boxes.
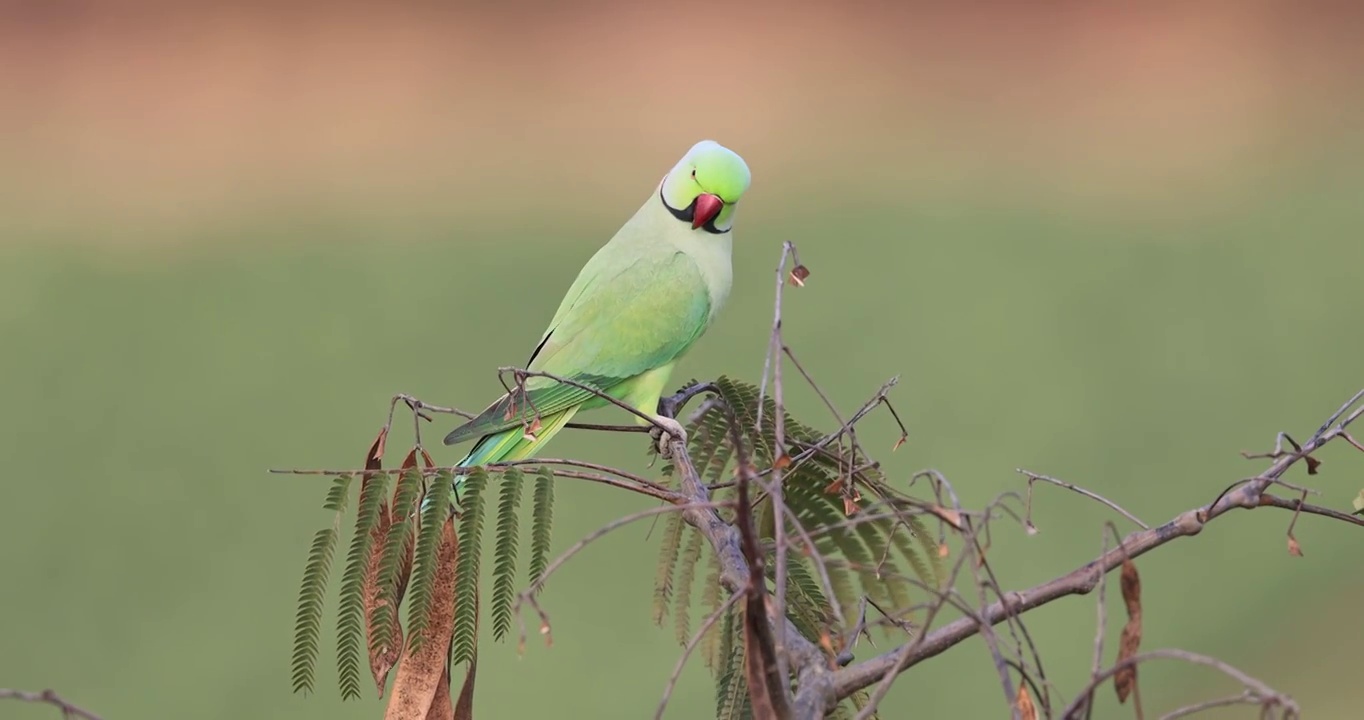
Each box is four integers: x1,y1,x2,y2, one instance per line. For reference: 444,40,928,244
383,518,461,720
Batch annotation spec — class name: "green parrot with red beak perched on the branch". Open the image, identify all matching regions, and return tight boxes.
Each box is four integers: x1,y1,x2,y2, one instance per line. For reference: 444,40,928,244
445,140,752,488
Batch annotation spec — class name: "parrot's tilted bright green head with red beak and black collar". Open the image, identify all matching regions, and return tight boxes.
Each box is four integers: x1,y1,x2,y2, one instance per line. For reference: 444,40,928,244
659,140,752,235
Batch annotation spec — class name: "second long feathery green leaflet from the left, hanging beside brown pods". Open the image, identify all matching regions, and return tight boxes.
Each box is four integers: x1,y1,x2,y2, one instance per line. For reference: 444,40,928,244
337,473,387,700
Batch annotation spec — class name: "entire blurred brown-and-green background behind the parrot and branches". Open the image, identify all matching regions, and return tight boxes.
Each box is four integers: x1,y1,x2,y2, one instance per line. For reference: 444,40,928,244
0,1,1364,719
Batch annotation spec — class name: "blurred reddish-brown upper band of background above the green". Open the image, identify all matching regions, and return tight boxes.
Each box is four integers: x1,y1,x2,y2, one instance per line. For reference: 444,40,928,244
10,1,1364,237
